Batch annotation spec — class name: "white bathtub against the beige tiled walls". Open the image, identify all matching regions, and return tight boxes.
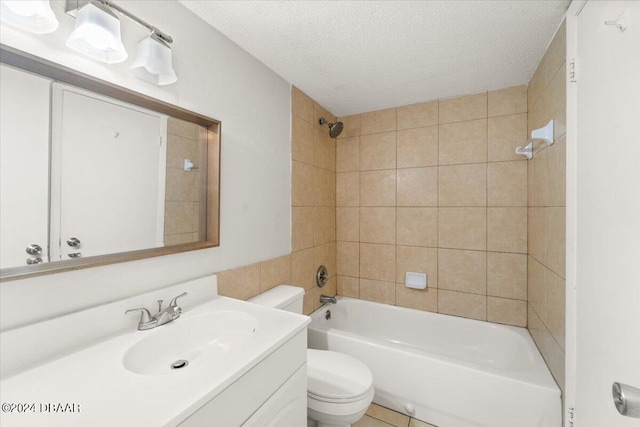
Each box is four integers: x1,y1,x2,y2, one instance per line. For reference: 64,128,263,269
308,297,562,427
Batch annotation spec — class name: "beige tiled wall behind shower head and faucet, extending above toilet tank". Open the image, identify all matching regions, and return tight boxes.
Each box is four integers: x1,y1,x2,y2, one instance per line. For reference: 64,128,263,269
218,87,337,314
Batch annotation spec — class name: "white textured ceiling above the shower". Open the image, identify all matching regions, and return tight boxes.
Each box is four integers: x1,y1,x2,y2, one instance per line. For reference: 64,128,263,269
181,0,570,116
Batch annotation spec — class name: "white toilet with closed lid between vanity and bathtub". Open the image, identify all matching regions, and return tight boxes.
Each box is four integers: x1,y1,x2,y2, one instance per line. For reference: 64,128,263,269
249,285,374,427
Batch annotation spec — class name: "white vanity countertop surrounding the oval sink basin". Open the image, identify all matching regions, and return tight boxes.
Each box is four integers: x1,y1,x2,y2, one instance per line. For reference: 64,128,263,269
0,297,310,427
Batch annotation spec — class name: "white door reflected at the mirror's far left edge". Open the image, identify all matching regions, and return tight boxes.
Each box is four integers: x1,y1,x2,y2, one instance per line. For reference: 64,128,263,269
0,65,51,268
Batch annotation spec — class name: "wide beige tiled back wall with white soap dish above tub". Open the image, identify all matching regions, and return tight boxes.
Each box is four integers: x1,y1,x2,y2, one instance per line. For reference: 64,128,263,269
336,86,527,326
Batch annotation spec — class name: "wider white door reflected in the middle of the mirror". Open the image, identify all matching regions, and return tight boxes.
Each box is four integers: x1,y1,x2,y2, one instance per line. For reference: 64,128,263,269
51,83,167,260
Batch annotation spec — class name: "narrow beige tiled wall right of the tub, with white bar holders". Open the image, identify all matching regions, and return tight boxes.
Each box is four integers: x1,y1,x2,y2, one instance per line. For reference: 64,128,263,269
527,20,566,391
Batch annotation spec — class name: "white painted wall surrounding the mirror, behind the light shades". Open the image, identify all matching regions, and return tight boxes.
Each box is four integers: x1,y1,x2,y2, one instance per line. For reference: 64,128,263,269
0,0,291,330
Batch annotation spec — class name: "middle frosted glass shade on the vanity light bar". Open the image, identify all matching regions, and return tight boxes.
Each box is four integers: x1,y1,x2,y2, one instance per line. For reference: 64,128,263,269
67,3,127,64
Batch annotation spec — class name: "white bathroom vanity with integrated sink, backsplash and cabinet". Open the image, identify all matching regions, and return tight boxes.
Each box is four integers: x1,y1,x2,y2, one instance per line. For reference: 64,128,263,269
0,277,310,427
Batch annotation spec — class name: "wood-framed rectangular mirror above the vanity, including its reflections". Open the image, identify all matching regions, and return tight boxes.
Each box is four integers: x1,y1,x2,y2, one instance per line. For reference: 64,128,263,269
0,45,220,281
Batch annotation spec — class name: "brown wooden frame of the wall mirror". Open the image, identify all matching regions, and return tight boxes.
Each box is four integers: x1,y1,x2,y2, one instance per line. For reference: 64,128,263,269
0,44,222,282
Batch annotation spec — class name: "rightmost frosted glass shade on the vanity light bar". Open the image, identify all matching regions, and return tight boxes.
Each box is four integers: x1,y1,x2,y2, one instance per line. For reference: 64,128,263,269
131,34,178,86
